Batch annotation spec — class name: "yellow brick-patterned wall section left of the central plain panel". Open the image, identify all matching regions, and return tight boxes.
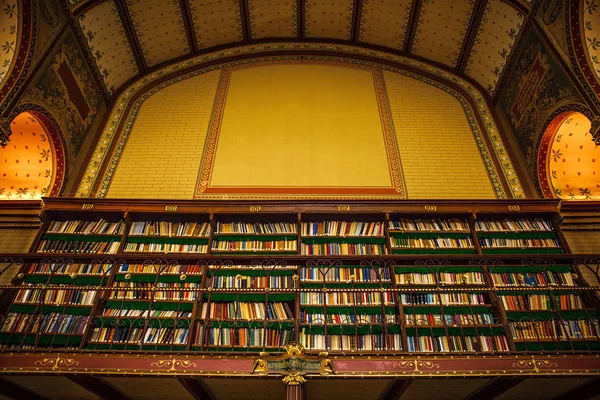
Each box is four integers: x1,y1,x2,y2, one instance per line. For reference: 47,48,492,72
107,71,220,199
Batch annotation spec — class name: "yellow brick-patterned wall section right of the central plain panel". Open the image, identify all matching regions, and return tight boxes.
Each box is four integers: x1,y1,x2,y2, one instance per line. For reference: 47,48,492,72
384,72,495,199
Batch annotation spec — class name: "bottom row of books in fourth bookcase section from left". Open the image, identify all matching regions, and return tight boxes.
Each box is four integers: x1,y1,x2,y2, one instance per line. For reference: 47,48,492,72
298,331,402,351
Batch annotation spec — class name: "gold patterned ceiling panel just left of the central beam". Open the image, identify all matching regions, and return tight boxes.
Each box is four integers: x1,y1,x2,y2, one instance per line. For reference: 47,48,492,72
248,0,298,39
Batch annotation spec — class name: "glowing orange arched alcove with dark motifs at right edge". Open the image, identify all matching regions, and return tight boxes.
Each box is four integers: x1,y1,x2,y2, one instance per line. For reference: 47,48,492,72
538,111,600,200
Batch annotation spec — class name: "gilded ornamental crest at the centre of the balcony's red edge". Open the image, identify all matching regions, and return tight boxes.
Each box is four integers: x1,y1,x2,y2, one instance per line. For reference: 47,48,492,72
250,342,335,386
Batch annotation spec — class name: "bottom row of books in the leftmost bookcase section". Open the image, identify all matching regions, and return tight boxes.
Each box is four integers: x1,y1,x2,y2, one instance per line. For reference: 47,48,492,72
0,312,89,335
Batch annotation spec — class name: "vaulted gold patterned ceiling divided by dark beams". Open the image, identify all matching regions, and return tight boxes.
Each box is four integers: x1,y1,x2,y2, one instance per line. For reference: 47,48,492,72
69,0,528,96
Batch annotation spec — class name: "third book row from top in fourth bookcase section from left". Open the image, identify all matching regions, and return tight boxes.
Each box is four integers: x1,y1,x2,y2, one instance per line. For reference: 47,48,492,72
300,267,390,282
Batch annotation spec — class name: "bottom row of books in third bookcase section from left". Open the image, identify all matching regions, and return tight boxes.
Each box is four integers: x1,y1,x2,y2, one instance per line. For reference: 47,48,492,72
195,328,293,347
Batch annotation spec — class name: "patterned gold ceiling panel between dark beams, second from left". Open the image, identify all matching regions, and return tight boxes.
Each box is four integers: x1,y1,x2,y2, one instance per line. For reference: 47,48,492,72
125,0,190,67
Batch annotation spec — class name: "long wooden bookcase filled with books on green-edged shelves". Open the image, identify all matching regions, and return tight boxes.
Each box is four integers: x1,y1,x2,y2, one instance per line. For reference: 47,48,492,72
0,199,600,356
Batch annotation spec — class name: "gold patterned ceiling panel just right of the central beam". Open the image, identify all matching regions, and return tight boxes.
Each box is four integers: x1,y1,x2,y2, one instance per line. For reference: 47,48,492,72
304,0,354,40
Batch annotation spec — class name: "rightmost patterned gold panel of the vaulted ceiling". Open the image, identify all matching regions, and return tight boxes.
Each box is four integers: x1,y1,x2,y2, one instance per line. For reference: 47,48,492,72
465,0,525,95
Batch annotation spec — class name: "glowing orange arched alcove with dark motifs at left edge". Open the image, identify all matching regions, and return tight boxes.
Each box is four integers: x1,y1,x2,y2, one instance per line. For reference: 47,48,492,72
0,111,65,200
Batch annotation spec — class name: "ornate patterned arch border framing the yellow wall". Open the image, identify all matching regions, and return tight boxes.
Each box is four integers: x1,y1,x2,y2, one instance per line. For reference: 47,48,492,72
76,42,524,198
